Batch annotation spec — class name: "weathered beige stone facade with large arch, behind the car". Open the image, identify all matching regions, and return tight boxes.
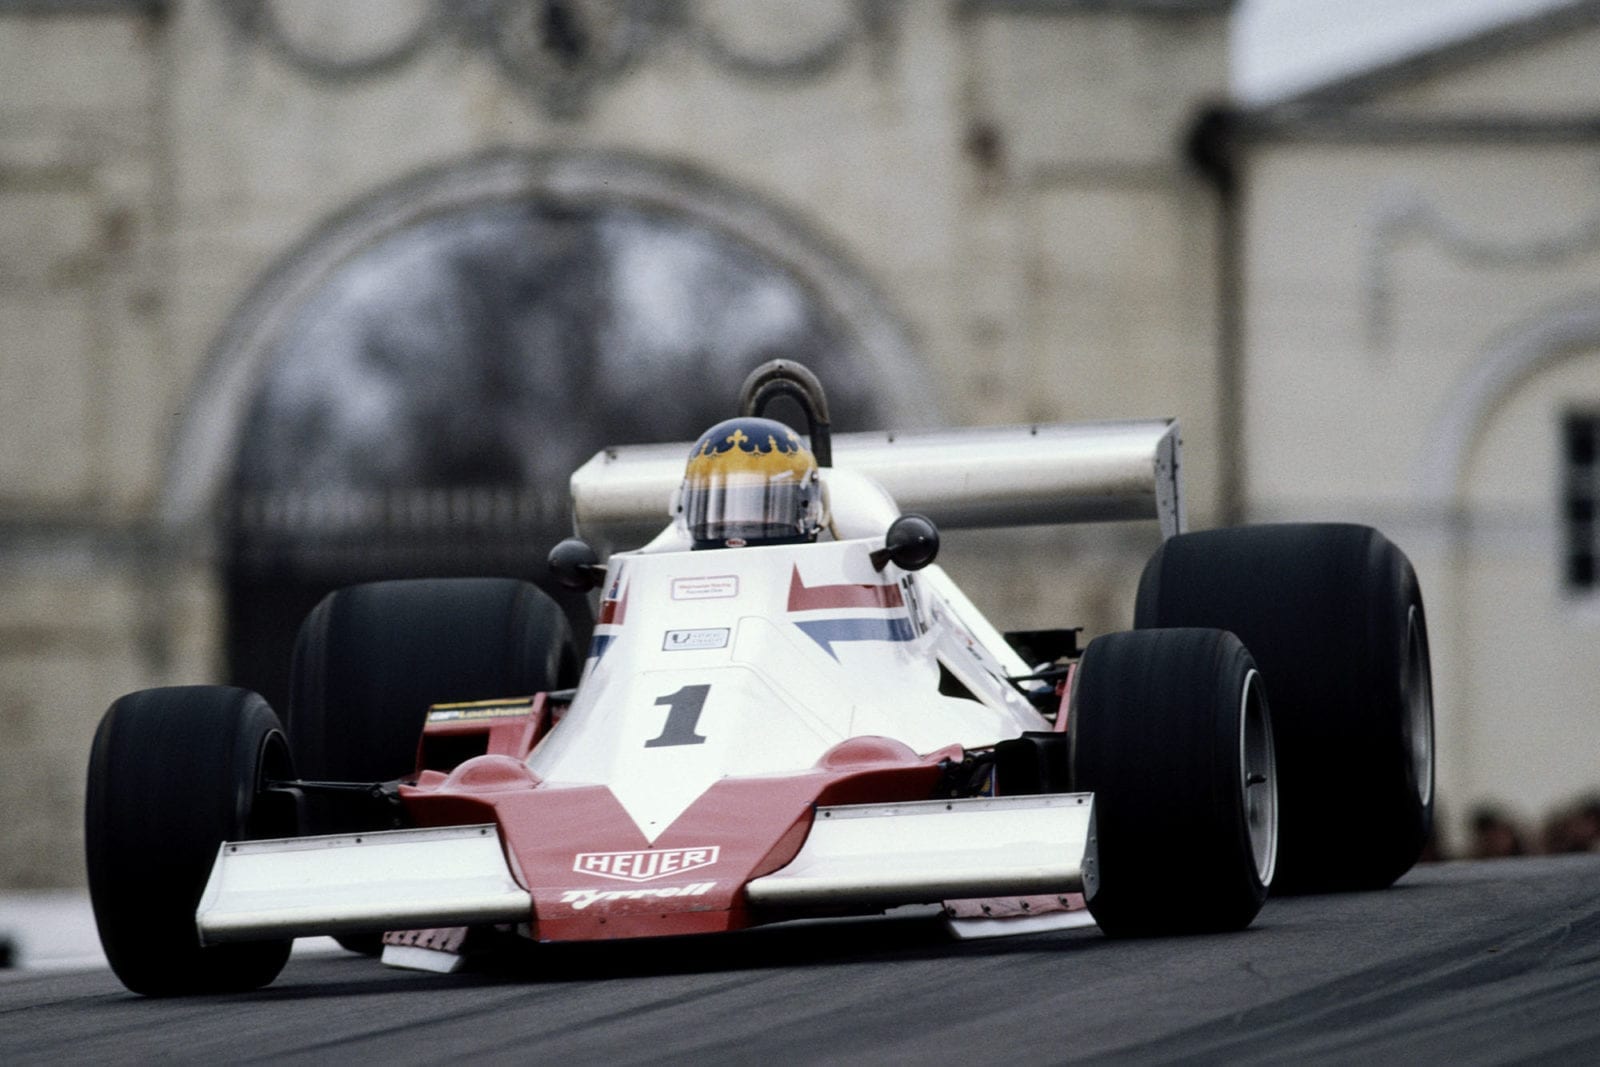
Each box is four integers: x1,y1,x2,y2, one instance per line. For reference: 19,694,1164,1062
0,0,1235,886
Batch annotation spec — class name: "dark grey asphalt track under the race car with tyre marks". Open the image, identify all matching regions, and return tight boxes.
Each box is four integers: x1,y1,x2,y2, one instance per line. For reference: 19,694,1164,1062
0,856,1600,1065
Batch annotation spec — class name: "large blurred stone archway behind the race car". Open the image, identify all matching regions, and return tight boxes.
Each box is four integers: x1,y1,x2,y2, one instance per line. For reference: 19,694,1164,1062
168,154,930,713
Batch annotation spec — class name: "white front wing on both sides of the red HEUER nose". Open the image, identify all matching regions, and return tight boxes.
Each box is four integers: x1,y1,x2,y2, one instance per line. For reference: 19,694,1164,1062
195,793,1096,944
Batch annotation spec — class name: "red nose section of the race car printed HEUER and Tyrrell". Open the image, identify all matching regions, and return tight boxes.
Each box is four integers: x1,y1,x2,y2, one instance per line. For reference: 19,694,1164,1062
400,751,958,941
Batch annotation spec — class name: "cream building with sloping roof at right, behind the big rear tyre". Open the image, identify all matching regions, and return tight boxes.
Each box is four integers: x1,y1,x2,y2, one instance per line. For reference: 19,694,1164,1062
1221,0,1600,840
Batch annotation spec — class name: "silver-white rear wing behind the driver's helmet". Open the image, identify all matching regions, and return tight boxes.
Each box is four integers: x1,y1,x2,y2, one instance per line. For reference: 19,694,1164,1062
571,419,1184,545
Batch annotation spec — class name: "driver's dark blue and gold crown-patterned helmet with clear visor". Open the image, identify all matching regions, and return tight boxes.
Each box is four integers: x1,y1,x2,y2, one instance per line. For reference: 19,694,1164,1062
677,418,822,549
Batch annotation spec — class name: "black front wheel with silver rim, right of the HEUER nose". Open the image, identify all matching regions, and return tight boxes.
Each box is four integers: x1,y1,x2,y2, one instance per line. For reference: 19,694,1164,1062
1067,629,1278,937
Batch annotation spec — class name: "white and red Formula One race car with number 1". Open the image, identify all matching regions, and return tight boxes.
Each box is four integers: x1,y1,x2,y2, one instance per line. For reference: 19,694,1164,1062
86,362,1434,995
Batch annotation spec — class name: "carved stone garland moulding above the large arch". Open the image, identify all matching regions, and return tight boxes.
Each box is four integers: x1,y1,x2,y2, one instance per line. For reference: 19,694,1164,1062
218,0,899,118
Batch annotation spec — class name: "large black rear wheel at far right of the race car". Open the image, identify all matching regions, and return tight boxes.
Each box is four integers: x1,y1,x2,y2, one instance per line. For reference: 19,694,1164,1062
1134,525,1434,893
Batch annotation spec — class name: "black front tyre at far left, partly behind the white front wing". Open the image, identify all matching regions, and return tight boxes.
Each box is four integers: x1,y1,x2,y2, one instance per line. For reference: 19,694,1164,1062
83,686,296,997
